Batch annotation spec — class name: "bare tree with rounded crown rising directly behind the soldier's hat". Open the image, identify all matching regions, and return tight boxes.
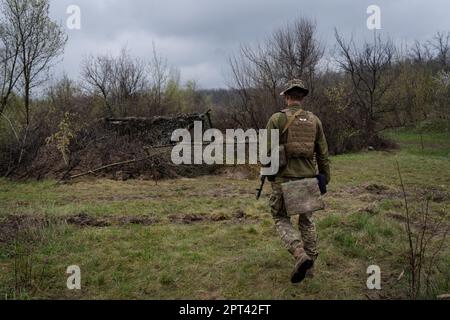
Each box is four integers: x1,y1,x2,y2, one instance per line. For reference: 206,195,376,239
229,19,323,128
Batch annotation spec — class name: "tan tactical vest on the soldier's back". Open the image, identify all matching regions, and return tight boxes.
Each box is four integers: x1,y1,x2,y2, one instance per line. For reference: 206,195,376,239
282,109,317,159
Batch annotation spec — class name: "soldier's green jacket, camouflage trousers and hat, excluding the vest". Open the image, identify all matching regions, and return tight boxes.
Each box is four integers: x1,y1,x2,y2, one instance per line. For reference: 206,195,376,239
267,80,331,260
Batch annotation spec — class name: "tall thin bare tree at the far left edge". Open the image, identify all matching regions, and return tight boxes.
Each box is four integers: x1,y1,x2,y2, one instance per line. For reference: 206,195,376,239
0,0,67,170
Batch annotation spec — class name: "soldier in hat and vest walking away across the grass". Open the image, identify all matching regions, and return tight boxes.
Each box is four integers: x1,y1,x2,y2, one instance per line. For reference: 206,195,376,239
267,80,331,283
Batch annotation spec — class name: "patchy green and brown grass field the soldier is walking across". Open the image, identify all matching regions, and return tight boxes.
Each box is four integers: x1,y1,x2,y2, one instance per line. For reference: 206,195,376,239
0,131,450,299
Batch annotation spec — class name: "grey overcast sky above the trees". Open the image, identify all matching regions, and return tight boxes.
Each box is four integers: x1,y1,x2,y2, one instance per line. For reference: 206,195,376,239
51,0,450,88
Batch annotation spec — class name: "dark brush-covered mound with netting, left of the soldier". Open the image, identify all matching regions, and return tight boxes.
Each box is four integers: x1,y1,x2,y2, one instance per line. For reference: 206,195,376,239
18,114,217,180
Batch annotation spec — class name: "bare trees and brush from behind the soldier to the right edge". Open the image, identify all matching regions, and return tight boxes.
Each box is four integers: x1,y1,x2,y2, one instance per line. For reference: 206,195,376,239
228,18,450,153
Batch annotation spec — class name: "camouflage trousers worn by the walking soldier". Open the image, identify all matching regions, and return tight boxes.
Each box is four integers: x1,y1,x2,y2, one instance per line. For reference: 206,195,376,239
270,178,318,259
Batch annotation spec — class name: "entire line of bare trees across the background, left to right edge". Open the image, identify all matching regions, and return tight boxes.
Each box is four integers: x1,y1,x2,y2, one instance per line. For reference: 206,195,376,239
0,0,450,175
